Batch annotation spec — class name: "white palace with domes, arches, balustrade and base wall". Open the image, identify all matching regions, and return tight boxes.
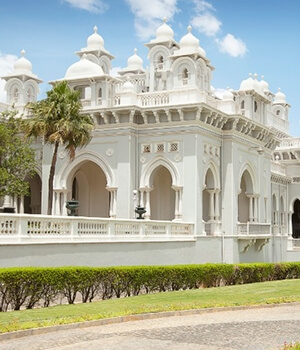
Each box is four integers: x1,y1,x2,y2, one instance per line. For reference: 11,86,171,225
0,21,300,266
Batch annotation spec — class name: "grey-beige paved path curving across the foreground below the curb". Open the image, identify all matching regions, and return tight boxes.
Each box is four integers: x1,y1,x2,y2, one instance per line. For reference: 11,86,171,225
0,303,300,350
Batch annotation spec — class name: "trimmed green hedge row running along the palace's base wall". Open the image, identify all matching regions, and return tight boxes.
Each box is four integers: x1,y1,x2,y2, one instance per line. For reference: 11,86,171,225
0,263,300,311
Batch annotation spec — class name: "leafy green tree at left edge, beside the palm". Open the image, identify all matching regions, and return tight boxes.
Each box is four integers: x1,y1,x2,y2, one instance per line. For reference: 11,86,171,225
0,111,36,197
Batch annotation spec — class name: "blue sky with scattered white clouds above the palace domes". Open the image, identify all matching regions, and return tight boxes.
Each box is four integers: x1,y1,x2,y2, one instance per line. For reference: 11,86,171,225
0,0,300,137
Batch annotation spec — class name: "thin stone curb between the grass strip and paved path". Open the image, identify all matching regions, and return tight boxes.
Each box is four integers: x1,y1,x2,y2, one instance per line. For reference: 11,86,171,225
0,302,300,341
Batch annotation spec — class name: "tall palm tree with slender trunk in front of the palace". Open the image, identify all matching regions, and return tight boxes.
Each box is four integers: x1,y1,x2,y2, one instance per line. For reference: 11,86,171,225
23,81,94,215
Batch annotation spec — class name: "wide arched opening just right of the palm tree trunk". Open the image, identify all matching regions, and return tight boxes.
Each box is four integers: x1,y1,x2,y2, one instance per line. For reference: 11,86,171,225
71,161,110,217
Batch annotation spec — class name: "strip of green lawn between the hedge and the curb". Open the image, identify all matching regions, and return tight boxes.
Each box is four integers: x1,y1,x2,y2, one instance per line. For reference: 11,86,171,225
0,279,300,333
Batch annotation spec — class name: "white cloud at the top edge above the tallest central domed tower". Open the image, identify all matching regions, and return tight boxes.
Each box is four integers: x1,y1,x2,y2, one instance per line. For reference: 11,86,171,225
125,0,178,40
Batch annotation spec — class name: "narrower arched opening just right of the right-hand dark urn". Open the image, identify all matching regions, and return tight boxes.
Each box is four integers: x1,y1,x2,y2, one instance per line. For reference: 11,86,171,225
150,165,175,220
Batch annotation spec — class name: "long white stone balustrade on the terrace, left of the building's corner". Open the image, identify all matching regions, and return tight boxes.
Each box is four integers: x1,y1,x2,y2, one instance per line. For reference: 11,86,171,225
0,214,195,244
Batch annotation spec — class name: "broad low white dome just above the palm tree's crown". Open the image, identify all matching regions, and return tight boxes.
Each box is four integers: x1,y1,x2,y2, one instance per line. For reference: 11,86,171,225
65,54,104,79
